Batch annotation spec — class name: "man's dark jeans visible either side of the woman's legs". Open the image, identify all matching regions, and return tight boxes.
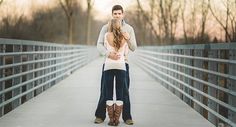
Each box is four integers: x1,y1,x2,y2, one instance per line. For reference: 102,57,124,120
95,63,132,121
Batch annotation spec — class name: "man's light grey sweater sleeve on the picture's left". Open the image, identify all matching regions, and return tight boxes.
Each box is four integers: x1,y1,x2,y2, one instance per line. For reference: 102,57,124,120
97,25,108,55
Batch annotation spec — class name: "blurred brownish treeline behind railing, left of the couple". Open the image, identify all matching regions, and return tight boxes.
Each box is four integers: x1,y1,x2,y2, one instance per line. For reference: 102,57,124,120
0,2,103,44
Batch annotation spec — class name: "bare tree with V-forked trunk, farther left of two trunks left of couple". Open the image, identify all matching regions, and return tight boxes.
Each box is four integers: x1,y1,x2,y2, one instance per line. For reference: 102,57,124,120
59,0,76,44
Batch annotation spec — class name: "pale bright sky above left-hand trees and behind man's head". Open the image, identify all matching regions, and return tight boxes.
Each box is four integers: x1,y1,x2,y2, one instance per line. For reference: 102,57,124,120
0,0,136,20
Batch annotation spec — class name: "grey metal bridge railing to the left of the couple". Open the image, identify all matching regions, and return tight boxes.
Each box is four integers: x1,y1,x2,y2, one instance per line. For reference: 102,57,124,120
0,39,98,117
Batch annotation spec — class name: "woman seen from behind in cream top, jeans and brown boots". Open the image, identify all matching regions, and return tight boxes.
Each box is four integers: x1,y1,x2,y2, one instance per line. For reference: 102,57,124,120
104,19,129,126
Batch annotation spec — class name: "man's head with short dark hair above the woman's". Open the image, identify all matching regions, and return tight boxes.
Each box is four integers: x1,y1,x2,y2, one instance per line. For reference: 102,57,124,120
112,5,124,20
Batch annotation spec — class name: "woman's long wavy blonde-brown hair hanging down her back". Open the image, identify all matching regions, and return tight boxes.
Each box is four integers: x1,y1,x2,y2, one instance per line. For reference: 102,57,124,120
109,19,124,51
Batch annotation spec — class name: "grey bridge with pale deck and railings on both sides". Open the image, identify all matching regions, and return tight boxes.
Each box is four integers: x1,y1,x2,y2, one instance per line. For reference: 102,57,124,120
0,39,236,127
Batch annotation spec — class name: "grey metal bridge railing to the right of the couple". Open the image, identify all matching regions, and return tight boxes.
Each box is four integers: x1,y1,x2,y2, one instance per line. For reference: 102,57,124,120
132,43,236,127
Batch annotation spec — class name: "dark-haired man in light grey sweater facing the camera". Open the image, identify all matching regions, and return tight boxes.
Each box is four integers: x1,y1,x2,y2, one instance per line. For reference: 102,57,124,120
94,5,137,125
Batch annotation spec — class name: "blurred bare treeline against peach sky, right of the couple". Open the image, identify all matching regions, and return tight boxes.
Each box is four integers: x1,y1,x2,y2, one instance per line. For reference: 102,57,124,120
126,0,236,45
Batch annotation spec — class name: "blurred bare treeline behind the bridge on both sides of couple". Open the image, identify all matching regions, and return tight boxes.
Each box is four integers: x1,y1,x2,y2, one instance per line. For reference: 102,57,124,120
0,0,236,45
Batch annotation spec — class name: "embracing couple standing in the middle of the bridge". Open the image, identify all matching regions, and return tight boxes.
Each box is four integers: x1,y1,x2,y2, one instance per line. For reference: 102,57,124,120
94,5,137,126
